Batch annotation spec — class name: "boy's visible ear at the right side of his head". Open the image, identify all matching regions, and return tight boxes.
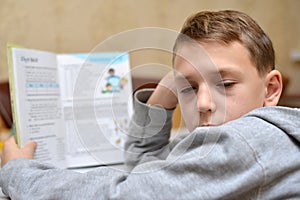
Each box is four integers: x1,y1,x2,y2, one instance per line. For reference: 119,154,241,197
264,70,282,106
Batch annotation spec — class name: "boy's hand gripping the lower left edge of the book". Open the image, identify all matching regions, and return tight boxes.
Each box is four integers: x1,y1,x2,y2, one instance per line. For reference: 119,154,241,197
1,137,37,167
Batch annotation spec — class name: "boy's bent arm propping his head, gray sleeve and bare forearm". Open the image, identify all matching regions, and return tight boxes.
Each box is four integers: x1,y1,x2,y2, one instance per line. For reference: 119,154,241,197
125,72,177,168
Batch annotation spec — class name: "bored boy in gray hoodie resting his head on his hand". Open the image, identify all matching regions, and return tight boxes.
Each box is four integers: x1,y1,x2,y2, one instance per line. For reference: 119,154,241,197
0,11,300,199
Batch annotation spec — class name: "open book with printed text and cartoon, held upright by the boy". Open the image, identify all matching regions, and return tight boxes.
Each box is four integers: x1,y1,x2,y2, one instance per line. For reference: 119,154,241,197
8,45,132,168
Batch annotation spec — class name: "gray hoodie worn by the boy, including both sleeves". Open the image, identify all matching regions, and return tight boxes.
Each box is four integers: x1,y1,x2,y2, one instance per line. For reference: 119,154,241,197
0,91,300,200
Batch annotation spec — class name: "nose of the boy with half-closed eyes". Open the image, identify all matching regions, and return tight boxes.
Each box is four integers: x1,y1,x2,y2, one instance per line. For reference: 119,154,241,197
197,84,216,113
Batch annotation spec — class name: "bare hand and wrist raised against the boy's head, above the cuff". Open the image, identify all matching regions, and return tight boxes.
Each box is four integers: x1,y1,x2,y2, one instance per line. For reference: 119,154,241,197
147,71,178,109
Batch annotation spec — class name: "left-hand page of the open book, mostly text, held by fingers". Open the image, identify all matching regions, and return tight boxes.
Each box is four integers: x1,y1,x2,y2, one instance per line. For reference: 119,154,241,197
10,48,65,168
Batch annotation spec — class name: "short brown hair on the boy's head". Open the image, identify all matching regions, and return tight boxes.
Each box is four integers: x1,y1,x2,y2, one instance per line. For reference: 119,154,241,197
173,10,275,76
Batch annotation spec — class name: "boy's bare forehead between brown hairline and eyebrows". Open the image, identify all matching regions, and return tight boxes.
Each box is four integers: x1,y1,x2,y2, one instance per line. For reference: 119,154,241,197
174,42,257,76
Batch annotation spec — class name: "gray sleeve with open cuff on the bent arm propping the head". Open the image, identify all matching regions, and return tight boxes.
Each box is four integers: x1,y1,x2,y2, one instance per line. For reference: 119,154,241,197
125,89,173,168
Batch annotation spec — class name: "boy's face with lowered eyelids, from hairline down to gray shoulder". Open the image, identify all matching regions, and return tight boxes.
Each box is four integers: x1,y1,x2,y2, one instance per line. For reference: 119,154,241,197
174,42,266,131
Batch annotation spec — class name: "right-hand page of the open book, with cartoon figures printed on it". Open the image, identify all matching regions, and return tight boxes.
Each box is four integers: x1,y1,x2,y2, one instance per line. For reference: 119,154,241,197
58,52,132,168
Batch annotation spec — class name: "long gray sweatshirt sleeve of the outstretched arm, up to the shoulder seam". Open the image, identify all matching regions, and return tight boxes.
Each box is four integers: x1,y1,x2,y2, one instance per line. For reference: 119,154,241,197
0,122,264,200
